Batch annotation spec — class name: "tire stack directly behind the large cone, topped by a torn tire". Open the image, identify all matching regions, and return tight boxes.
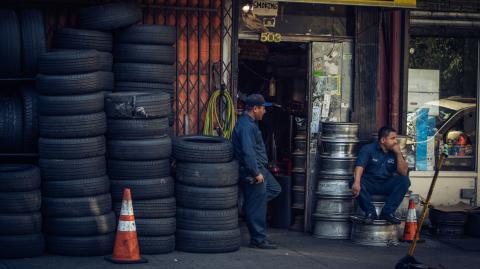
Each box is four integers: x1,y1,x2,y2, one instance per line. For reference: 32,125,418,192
105,92,175,254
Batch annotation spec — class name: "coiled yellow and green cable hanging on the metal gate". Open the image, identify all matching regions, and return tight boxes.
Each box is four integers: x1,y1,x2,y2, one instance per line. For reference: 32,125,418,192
203,90,236,139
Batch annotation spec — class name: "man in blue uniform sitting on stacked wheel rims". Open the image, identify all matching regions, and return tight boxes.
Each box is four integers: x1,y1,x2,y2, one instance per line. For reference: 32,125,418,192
352,127,410,224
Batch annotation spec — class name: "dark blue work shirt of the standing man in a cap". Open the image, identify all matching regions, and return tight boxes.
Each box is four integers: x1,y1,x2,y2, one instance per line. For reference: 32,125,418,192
232,112,268,177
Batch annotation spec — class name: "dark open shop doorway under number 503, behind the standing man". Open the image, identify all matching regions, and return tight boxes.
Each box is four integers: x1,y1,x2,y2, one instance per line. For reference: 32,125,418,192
238,40,310,231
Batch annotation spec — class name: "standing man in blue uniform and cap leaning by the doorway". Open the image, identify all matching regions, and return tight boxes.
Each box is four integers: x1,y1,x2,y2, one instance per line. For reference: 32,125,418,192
232,94,281,249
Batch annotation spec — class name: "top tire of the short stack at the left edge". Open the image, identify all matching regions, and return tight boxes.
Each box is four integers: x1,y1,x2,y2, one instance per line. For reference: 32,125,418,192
0,164,40,192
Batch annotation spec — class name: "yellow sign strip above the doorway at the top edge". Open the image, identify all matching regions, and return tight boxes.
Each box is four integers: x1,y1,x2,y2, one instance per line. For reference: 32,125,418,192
277,0,417,8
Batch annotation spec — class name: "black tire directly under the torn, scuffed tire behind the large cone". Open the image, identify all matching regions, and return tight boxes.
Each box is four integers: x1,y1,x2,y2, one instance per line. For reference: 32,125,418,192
108,118,170,139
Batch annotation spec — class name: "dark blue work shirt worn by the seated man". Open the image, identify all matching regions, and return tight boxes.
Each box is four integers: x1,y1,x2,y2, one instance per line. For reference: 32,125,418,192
355,142,397,179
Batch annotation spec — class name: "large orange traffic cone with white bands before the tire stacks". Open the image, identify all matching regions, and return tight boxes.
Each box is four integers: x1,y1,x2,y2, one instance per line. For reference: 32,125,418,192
105,188,148,263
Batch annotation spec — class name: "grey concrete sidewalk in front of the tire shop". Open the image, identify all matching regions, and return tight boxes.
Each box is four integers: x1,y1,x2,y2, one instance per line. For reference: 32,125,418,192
0,227,480,269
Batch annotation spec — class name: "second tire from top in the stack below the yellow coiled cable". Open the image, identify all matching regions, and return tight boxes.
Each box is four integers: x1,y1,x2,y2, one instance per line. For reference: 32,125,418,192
175,160,239,187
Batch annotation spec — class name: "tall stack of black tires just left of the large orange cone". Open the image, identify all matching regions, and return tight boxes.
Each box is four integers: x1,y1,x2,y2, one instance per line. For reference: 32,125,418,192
37,50,115,256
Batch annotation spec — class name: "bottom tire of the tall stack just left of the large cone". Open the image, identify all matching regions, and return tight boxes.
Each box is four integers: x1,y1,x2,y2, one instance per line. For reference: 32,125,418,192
45,233,115,256
